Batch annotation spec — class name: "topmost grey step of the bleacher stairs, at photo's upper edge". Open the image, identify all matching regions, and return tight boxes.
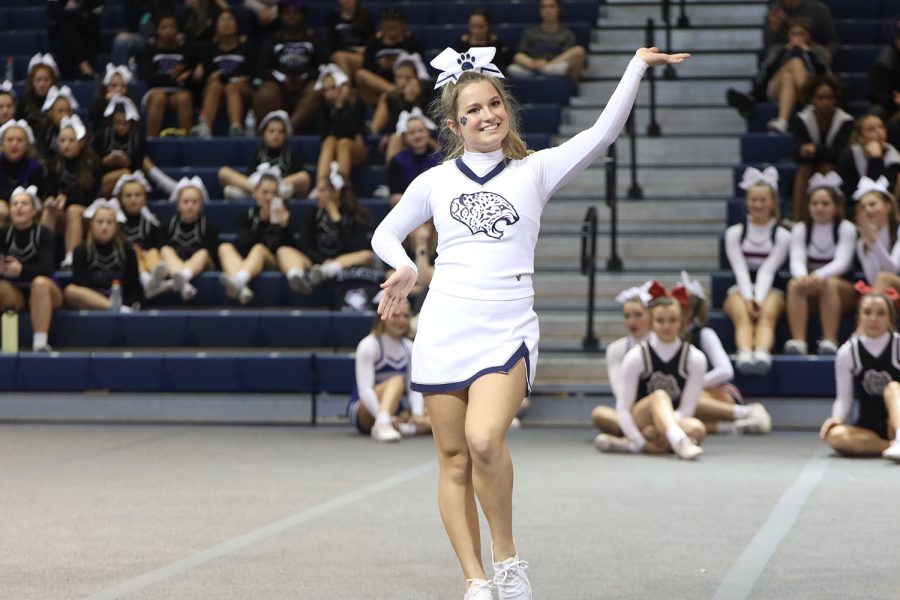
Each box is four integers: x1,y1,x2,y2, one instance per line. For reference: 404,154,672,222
597,0,766,27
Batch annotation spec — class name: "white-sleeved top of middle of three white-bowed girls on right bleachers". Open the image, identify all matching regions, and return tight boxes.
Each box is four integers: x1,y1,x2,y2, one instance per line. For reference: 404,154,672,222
790,220,856,279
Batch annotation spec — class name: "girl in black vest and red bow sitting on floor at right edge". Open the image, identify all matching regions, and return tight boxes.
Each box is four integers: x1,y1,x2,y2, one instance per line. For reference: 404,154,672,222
819,282,900,462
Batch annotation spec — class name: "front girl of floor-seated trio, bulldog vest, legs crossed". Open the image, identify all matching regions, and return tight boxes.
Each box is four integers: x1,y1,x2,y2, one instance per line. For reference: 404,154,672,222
594,290,706,460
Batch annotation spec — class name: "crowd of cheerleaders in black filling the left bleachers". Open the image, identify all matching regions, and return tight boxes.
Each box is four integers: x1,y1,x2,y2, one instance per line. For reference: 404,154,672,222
0,0,595,350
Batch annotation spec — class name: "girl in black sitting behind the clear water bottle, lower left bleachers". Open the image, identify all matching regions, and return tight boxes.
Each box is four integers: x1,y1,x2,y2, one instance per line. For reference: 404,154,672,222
63,198,143,312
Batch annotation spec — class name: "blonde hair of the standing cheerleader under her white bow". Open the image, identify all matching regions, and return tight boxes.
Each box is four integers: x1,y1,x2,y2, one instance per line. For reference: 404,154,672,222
431,71,531,160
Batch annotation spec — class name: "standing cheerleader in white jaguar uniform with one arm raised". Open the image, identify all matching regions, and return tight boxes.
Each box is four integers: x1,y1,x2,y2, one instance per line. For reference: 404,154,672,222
372,43,687,600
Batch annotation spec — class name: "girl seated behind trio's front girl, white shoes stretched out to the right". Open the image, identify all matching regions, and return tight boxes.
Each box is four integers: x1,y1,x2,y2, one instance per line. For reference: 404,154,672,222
675,271,772,434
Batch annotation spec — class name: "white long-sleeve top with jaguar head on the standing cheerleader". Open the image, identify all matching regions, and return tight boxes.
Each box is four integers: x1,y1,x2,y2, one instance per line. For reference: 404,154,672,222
372,58,647,300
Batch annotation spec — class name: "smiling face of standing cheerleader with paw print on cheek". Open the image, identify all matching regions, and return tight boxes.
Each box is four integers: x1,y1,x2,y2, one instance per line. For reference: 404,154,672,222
447,79,509,152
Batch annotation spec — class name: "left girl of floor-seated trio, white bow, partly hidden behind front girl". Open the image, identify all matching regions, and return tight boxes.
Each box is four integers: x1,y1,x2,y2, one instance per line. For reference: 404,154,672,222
591,281,653,436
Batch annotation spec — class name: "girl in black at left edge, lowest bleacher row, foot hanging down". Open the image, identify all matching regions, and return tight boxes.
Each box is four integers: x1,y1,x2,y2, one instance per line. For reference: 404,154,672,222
0,186,63,352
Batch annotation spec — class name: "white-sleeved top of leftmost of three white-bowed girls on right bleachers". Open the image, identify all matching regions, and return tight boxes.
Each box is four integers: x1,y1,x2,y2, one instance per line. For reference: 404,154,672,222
725,219,791,304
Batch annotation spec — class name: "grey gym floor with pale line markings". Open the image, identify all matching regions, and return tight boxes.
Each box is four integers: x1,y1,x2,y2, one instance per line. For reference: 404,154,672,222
0,425,900,600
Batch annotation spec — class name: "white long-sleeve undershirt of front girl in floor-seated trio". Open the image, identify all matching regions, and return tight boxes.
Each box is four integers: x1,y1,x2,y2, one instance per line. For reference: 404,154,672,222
616,335,706,452
